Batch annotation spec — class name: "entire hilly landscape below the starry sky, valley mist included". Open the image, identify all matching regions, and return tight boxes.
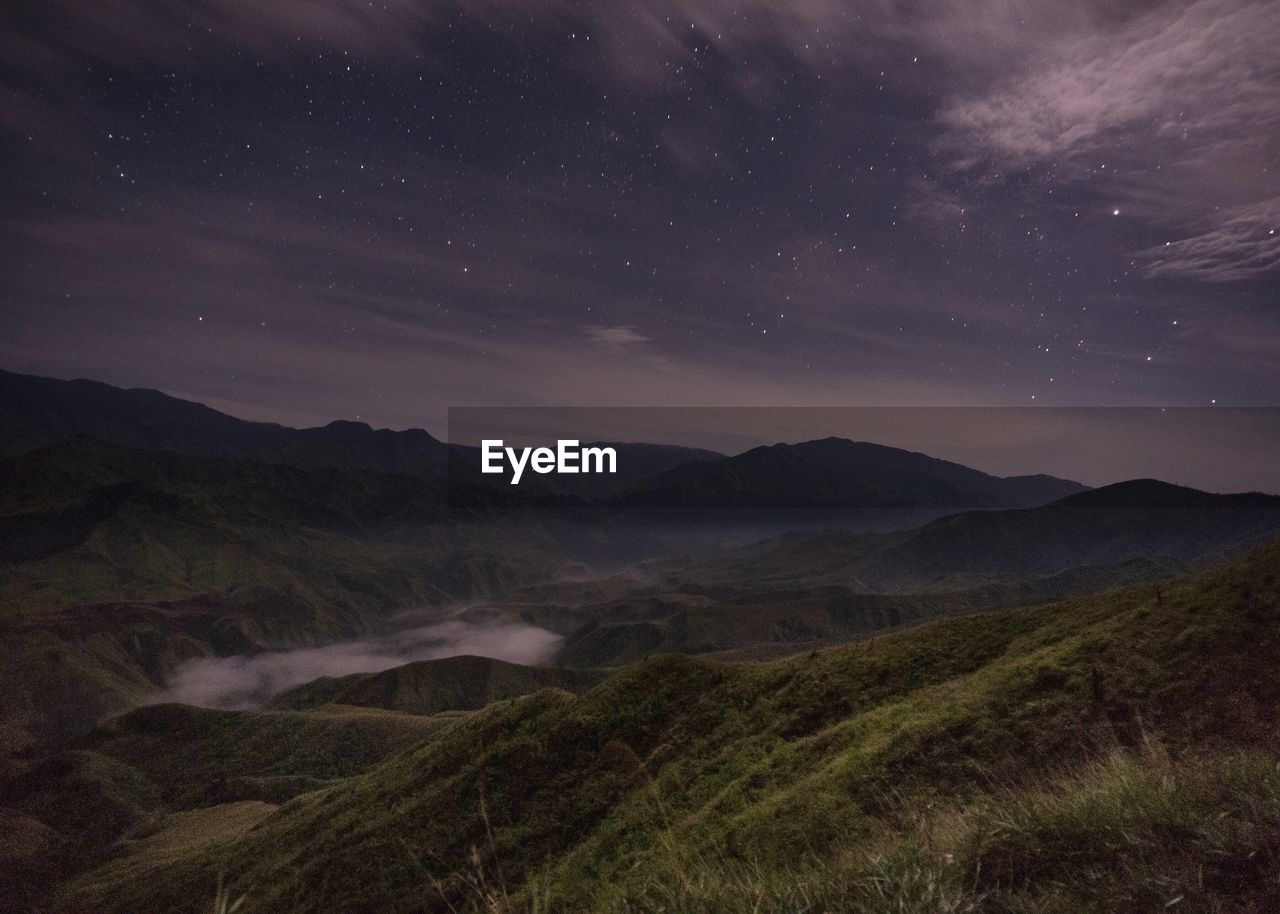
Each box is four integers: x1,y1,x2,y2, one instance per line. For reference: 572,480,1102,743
0,373,1280,914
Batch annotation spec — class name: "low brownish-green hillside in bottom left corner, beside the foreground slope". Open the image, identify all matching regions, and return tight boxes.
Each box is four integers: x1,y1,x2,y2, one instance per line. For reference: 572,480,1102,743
0,705,449,911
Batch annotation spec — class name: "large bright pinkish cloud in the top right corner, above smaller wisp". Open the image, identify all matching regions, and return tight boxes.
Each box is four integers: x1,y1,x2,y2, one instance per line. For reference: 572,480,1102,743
942,0,1280,165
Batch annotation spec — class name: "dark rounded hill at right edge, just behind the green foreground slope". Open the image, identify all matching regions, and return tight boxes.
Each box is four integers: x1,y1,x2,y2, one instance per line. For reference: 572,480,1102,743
676,480,1280,593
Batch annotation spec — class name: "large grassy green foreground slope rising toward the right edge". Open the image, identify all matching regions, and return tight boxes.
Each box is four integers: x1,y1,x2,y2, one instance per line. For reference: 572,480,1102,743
47,543,1280,914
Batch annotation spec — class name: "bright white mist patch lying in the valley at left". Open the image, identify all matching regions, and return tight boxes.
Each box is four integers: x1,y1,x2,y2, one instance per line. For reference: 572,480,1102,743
156,621,561,708
